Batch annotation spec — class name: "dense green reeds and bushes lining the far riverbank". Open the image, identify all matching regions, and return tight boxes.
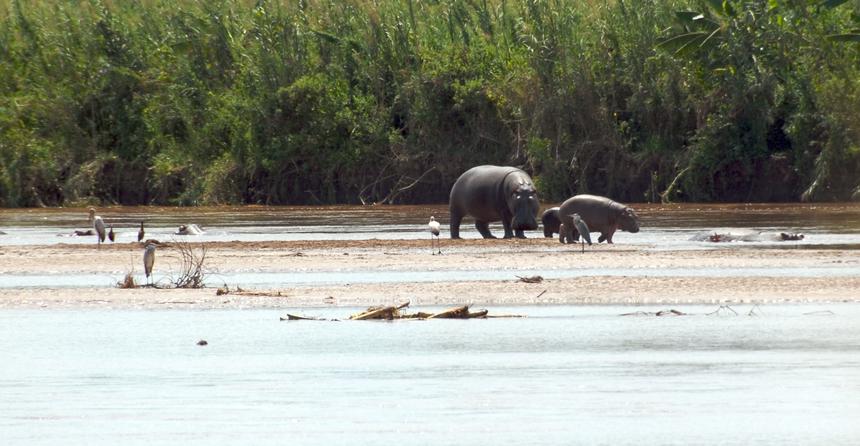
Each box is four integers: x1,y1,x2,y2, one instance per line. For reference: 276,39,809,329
0,0,860,206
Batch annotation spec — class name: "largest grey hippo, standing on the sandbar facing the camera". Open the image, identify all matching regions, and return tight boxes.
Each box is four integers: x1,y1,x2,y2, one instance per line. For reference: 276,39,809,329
449,166,540,239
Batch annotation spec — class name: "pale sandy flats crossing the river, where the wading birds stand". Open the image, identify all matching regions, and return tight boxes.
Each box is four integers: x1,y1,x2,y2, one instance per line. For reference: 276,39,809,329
0,239,860,309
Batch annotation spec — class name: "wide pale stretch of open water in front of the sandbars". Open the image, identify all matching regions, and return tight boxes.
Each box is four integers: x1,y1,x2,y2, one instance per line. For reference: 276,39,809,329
0,305,860,445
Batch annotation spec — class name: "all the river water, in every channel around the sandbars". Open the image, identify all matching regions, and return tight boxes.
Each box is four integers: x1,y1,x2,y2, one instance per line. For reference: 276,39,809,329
0,205,860,446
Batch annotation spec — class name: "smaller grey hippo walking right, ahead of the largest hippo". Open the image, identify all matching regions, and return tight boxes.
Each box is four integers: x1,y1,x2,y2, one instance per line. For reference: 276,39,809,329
558,194,639,243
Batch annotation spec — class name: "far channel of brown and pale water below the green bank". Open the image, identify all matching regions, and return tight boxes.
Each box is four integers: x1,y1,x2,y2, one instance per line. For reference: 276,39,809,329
0,204,860,249
